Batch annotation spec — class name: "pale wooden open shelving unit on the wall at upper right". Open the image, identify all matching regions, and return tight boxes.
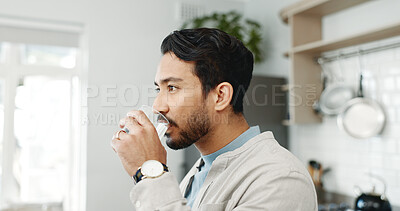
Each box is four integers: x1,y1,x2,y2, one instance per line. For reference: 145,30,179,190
280,0,400,124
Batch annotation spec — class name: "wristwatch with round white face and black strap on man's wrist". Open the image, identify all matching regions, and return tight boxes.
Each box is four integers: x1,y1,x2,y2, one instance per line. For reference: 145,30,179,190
133,160,168,184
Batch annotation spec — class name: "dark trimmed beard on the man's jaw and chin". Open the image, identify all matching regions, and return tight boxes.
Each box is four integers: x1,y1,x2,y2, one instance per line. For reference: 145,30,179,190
166,106,210,150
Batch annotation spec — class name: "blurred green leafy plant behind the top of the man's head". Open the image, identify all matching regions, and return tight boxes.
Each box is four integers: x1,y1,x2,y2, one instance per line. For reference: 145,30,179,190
182,11,264,63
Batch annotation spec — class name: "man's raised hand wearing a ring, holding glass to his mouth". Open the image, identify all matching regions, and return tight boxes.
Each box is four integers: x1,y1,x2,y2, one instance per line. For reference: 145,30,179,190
111,110,167,176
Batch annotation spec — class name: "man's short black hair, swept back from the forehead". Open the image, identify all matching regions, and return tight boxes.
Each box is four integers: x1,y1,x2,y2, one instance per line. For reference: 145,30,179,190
161,28,254,113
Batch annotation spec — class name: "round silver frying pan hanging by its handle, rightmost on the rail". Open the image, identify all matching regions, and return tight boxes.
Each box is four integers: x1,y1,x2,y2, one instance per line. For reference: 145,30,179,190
337,73,386,139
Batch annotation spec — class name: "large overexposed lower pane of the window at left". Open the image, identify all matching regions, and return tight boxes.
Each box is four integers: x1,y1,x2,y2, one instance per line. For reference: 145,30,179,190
14,76,71,202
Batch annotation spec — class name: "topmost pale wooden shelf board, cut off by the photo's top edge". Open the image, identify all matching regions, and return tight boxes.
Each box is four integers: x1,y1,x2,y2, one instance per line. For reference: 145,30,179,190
280,0,371,23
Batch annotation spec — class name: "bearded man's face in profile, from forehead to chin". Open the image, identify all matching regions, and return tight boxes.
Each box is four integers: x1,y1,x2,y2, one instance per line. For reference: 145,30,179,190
153,53,211,149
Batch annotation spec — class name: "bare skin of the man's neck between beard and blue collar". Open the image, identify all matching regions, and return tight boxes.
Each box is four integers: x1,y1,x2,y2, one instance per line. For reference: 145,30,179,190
195,114,249,155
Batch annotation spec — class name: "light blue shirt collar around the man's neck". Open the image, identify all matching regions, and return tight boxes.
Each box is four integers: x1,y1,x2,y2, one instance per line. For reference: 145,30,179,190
201,126,260,166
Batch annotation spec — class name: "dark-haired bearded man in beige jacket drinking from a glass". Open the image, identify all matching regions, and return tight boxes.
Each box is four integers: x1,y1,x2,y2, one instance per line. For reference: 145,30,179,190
112,28,317,211
